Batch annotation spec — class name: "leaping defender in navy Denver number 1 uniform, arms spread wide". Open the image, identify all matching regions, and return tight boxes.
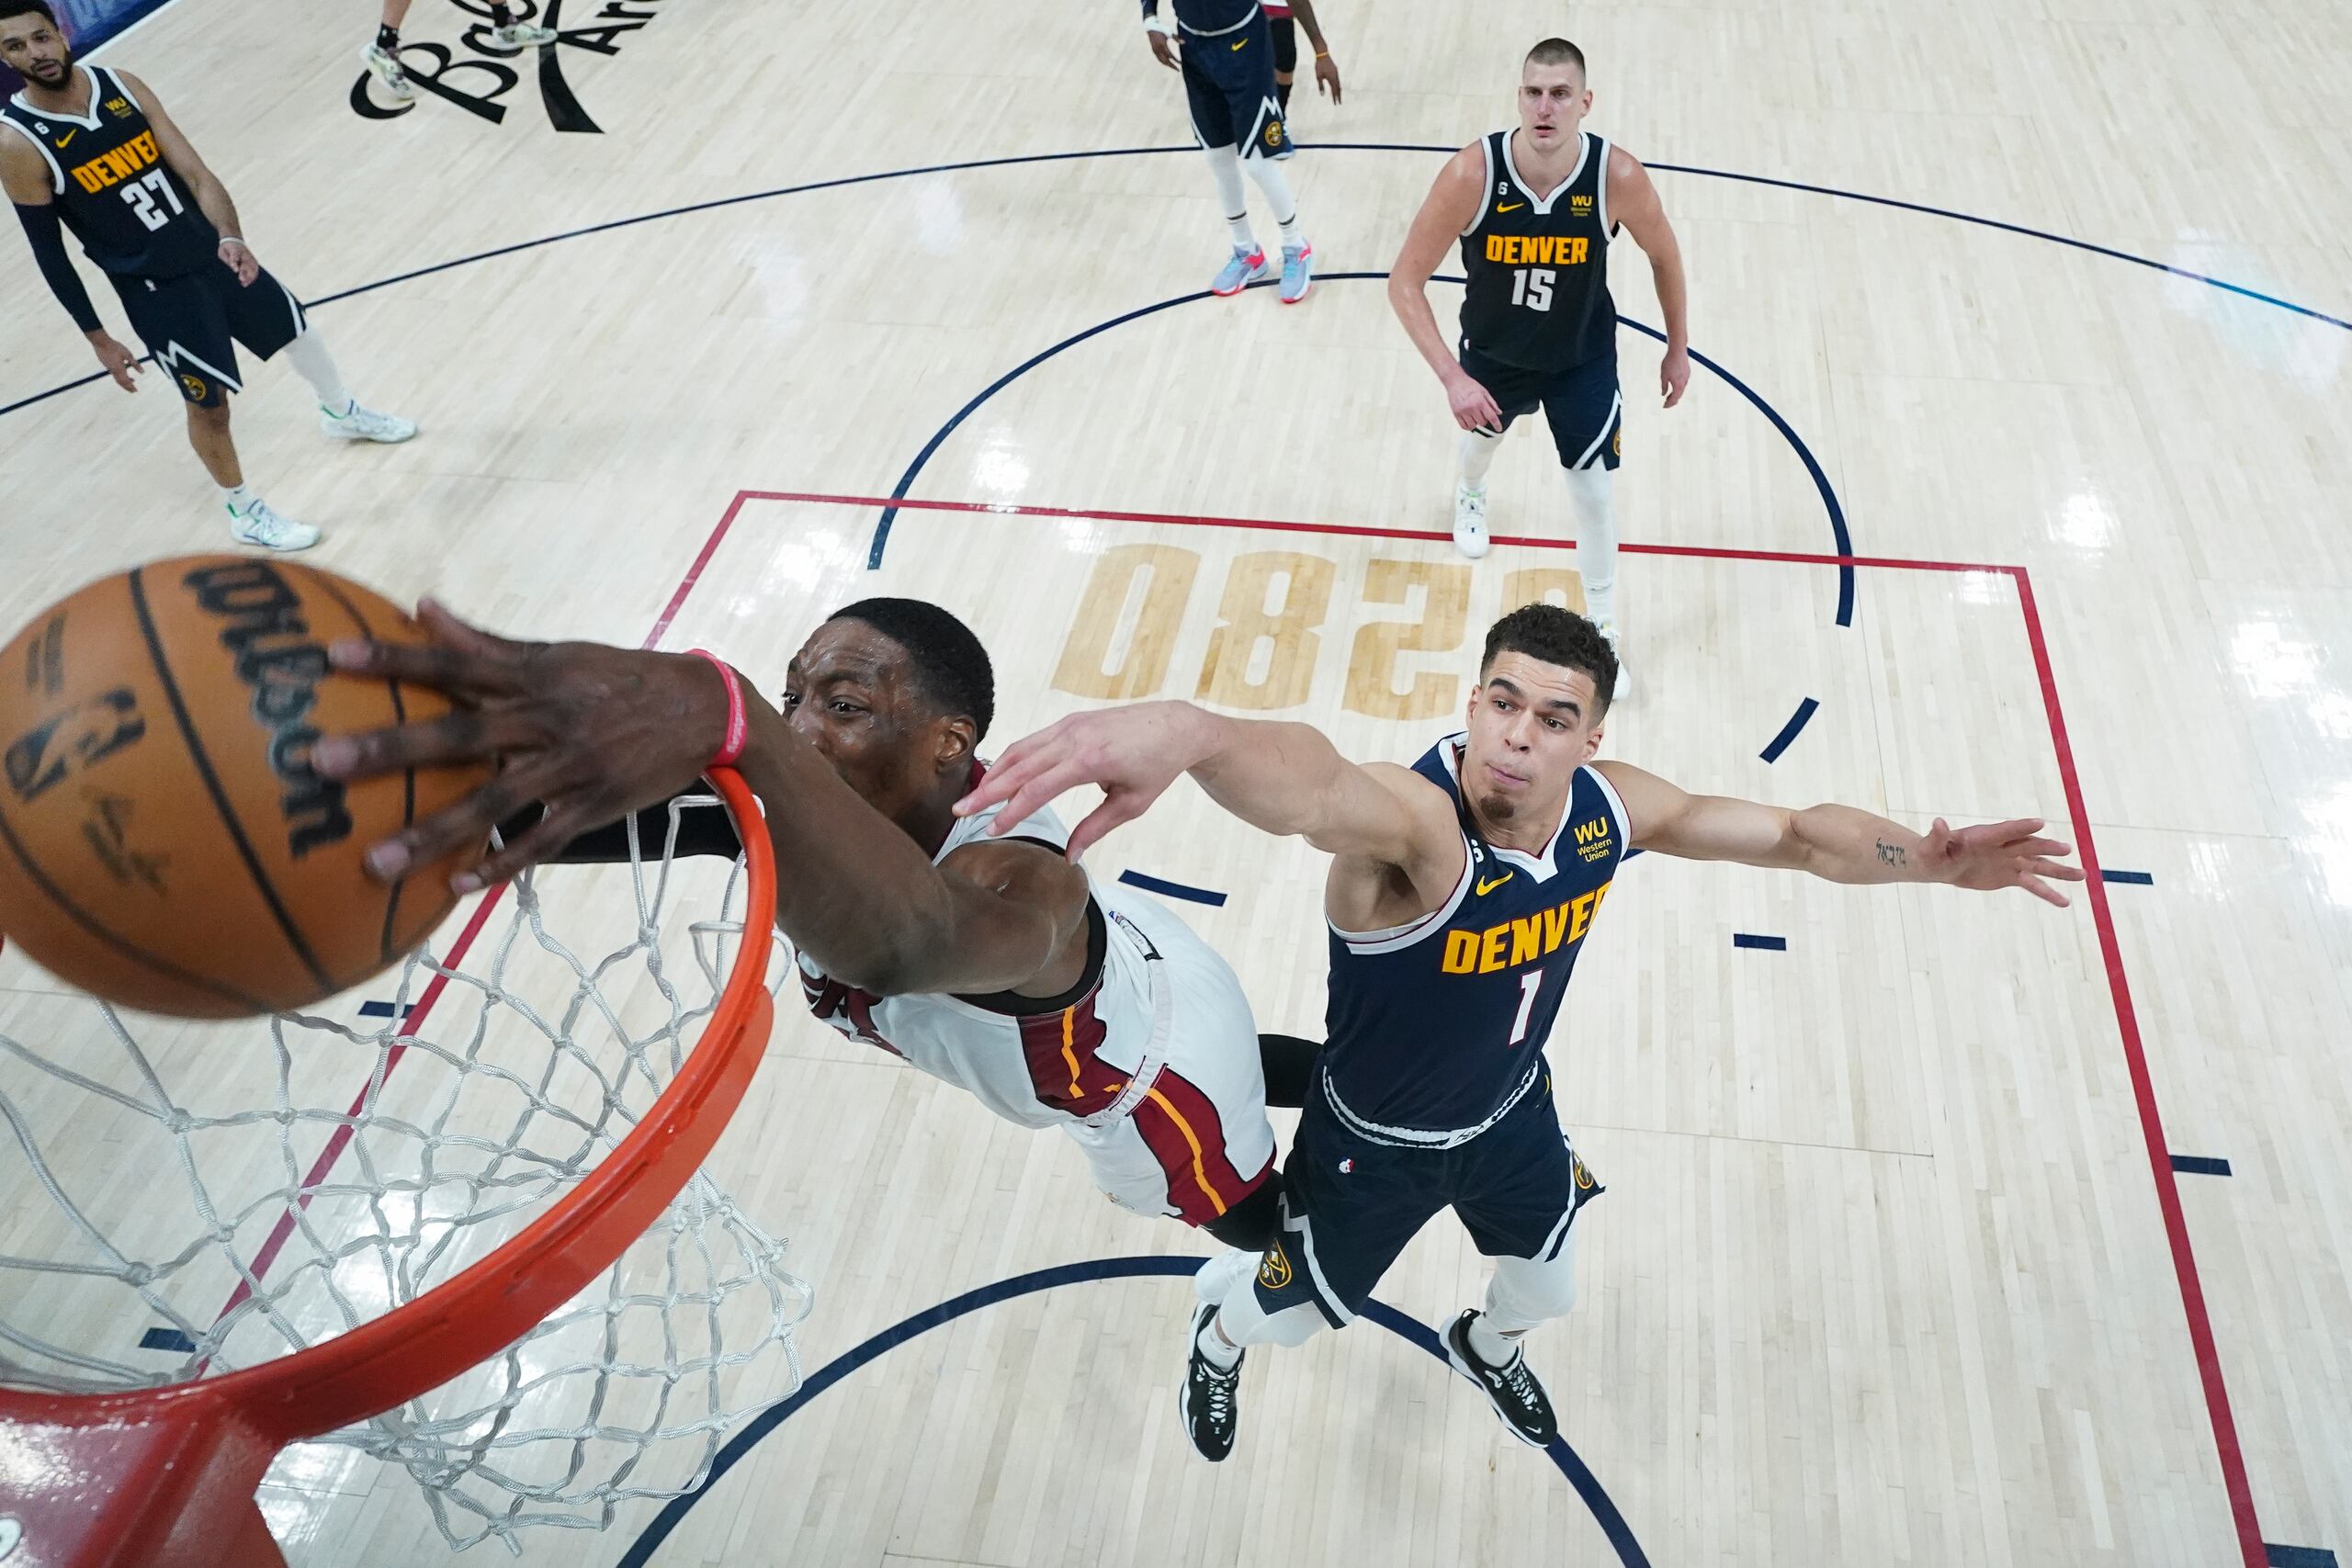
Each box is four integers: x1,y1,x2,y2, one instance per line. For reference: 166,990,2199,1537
957,604,2082,1460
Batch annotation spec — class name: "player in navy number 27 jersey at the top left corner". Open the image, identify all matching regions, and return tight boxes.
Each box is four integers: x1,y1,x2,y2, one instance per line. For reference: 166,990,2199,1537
0,0,416,550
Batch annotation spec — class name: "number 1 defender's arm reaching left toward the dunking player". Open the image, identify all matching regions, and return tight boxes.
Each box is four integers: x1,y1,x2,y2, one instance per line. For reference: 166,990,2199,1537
955,703,1461,882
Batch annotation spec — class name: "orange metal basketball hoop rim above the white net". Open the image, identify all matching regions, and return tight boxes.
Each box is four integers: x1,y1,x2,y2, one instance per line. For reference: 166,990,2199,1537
0,769,776,1457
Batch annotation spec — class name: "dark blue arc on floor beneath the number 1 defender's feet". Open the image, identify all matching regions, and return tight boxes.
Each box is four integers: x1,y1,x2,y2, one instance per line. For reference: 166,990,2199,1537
614,1253,1649,1568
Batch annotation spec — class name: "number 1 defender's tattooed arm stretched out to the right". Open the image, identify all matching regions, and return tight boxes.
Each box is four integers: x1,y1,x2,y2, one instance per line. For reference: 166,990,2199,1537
1595,761,2082,908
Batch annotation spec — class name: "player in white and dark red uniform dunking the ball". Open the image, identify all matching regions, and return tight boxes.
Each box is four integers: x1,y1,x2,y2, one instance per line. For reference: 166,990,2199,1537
312,600,1296,1248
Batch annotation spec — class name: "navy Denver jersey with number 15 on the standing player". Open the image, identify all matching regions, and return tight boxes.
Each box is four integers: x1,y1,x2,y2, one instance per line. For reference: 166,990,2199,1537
1463,131,1616,371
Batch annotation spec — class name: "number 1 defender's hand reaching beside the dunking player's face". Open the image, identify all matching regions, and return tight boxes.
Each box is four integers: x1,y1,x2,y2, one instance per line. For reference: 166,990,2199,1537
955,703,1200,861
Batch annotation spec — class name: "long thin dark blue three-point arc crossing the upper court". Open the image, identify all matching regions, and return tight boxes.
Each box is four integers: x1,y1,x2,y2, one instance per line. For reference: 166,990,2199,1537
0,141,2352,416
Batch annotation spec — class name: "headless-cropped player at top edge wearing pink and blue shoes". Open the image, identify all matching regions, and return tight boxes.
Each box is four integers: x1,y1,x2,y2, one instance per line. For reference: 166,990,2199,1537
1143,0,1339,306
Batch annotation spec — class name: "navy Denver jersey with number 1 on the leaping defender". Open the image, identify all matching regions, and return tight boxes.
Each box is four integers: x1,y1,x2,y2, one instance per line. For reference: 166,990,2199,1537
1322,736,1625,1143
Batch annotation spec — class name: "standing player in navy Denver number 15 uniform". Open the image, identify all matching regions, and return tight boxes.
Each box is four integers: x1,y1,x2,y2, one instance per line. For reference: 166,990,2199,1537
1387,38,1691,698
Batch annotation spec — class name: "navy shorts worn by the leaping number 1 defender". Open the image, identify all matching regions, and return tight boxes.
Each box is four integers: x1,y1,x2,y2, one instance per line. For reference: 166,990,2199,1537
1256,1069,1601,1328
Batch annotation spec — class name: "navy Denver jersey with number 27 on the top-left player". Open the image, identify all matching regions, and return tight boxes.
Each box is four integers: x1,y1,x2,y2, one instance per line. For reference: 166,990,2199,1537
0,66,221,277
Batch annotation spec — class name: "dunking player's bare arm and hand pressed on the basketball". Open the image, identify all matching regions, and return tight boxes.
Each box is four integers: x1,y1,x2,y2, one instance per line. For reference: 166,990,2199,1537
311,602,1087,995
